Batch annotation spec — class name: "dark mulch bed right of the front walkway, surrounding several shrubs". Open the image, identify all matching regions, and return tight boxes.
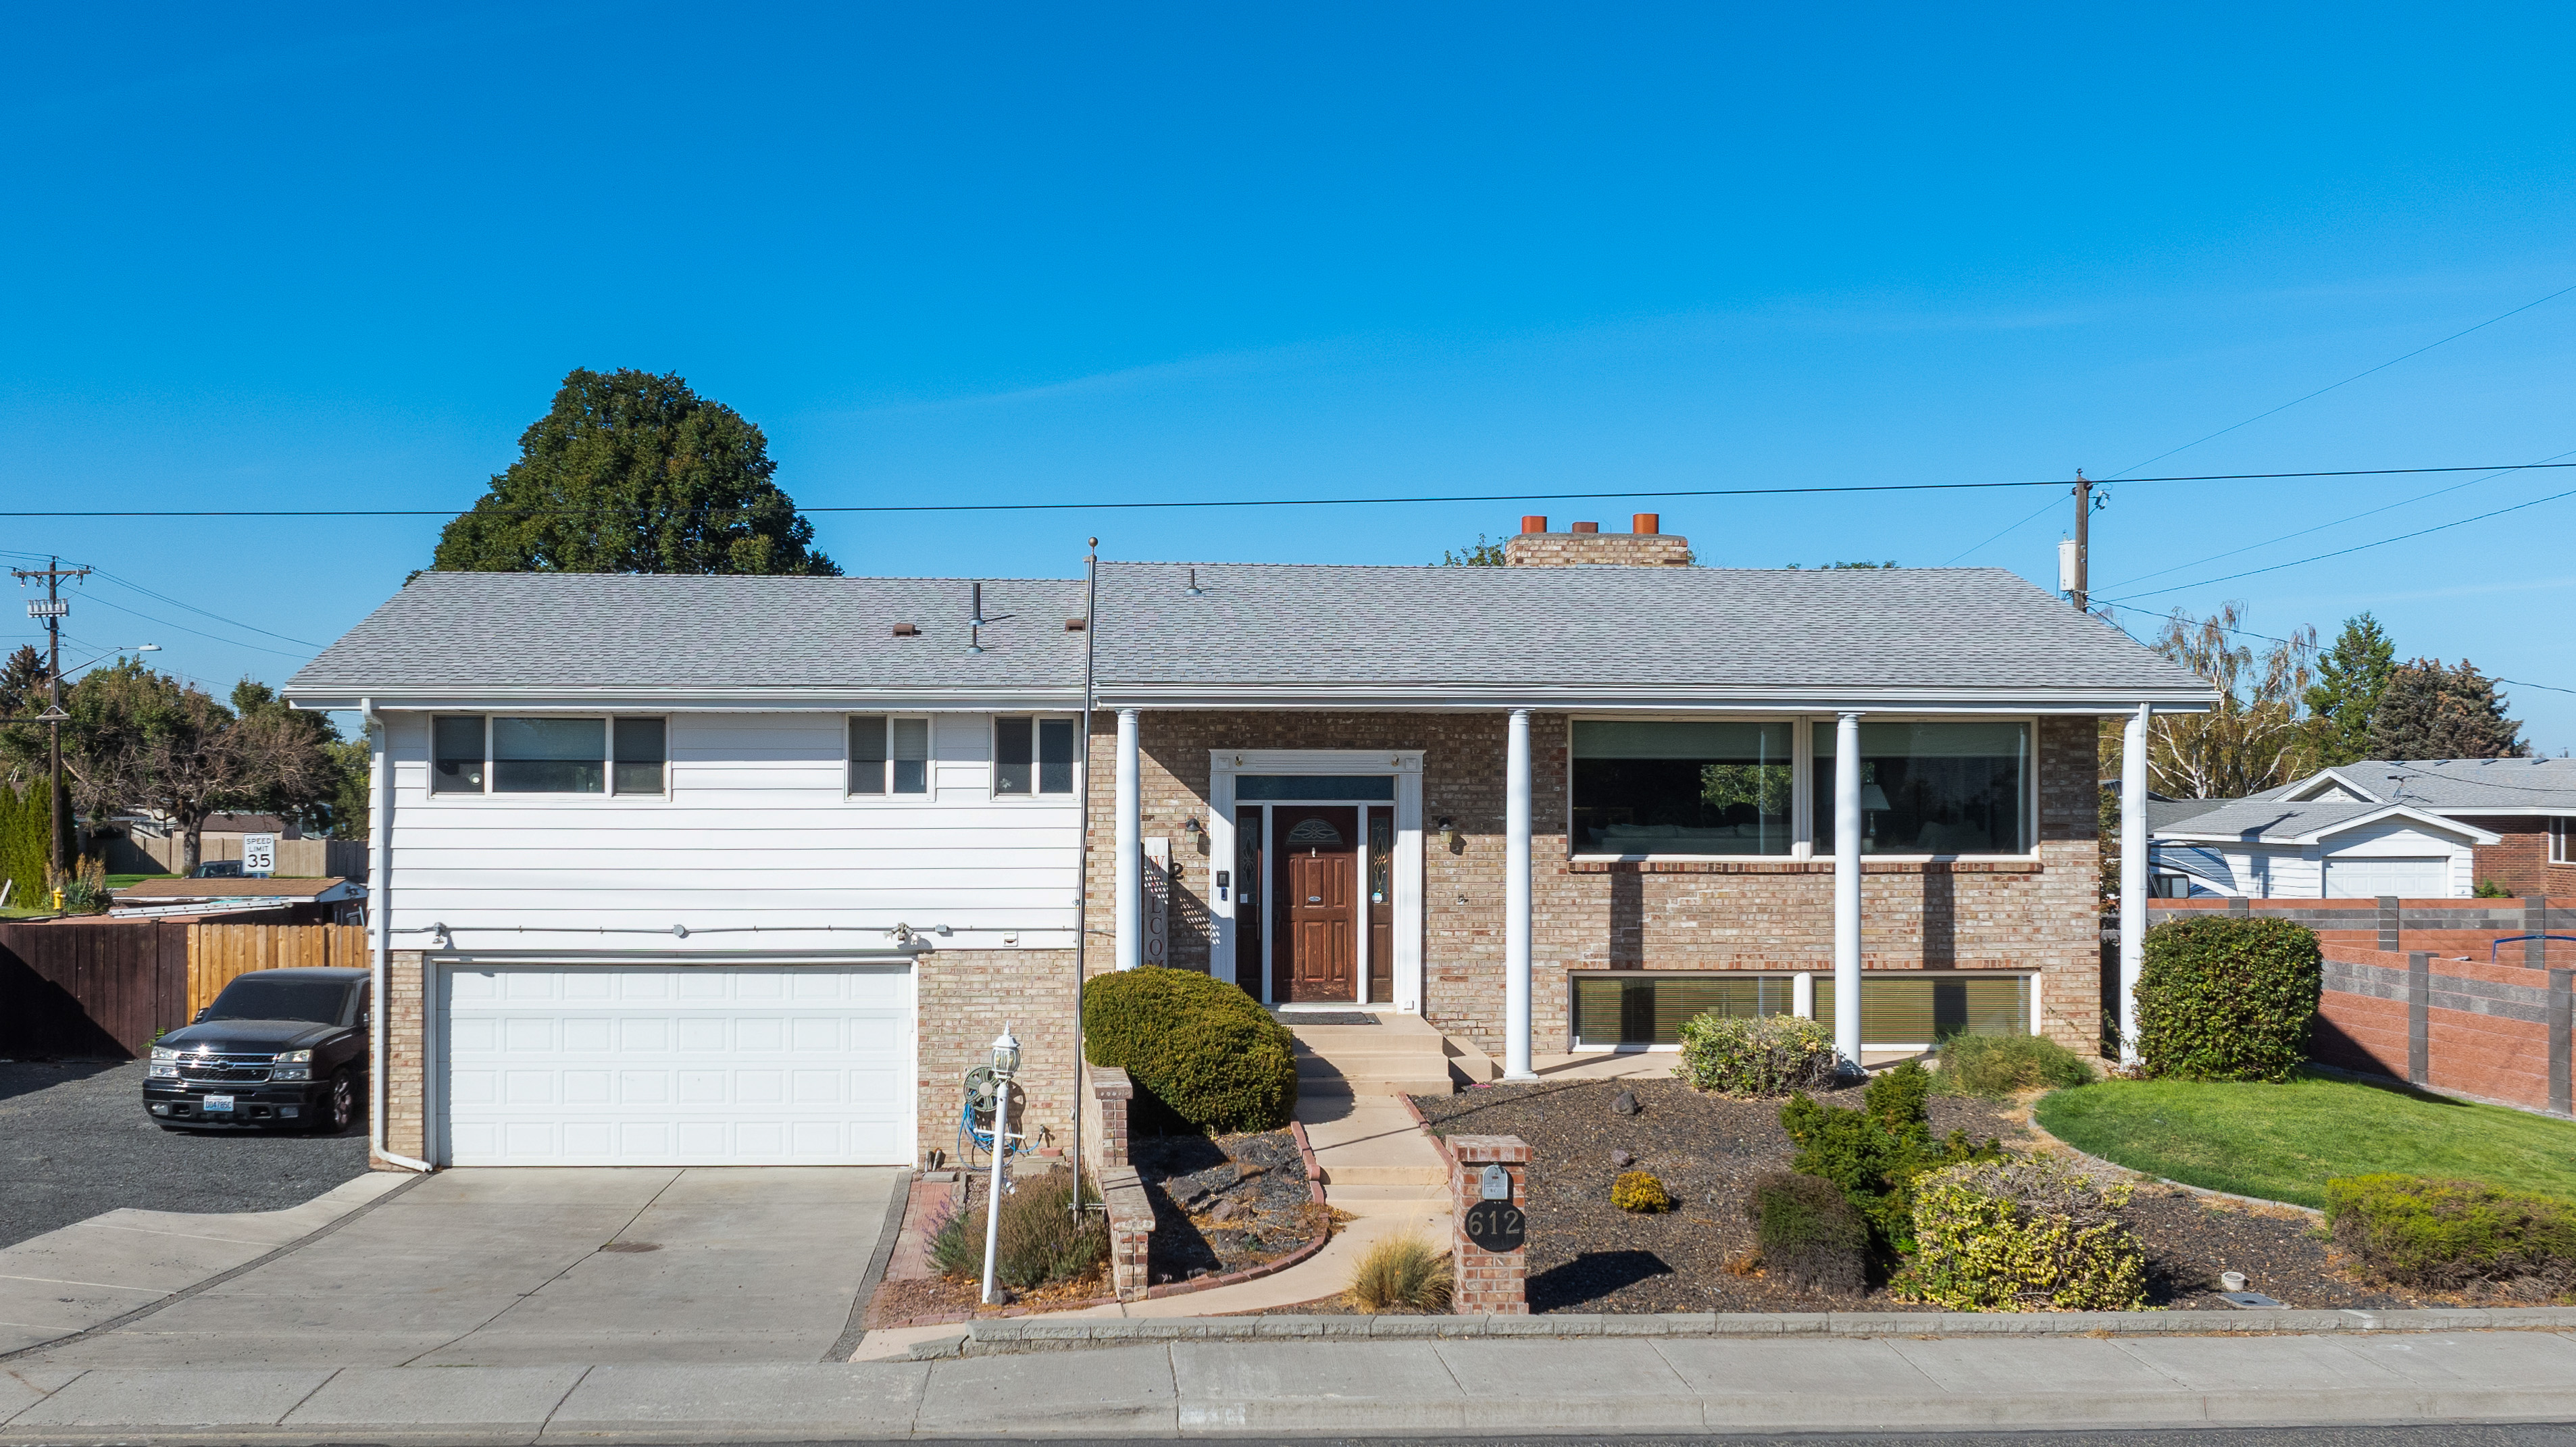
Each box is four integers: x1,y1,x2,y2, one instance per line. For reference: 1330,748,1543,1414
1414,1079,2440,1311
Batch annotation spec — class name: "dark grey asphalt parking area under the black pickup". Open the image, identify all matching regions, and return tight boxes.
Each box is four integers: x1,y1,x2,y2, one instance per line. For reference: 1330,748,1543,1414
0,1061,365,1246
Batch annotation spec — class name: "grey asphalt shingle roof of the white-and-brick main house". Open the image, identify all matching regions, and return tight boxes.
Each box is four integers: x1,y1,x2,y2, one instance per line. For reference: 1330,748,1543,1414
288,564,2205,695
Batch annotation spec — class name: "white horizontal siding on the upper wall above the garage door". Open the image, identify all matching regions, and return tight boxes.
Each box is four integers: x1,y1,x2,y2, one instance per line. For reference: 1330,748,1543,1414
389,713,1082,953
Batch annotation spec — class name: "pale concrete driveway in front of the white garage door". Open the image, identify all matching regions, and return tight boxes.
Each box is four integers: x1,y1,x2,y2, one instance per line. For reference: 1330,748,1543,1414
21,1167,907,1367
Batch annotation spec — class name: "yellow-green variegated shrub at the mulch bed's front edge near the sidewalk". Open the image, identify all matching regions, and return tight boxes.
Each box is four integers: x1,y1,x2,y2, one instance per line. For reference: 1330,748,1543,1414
1896,1156,2146,1311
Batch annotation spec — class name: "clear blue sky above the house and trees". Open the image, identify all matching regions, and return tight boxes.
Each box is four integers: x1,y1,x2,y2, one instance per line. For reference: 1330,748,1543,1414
0,5,2576,752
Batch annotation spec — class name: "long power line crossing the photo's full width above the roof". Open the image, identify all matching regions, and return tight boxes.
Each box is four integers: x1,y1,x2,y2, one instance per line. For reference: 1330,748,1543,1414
15,463,2576,517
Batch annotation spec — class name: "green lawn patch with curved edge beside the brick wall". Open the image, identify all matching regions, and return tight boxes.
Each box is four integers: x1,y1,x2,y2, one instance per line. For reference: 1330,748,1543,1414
2038,1061,2576,1205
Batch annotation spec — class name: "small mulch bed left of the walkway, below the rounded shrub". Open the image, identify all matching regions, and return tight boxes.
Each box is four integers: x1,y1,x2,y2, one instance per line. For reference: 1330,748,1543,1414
1128,1130,1327,1285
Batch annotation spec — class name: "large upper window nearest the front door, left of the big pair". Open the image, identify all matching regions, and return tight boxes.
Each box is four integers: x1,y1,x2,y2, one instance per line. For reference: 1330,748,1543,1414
1574,721,1798,855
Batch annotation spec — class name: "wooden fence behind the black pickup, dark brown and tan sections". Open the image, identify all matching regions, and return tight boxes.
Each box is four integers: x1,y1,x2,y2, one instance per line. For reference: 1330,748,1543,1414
0,919,368,1058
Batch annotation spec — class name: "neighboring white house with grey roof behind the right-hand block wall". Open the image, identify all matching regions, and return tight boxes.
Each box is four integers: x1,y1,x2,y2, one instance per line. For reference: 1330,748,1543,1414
2148,759,2576,898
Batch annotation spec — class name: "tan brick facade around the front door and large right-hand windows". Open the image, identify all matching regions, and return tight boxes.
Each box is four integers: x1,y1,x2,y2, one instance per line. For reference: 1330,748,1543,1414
1087,711,2102,1053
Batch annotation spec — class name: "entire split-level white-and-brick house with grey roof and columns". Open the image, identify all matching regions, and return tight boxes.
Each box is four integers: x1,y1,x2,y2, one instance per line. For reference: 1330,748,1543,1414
286,517,2208,1164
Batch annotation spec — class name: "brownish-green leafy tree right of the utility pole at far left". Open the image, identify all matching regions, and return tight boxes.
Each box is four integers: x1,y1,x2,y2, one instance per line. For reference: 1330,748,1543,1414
62,659,338,873
